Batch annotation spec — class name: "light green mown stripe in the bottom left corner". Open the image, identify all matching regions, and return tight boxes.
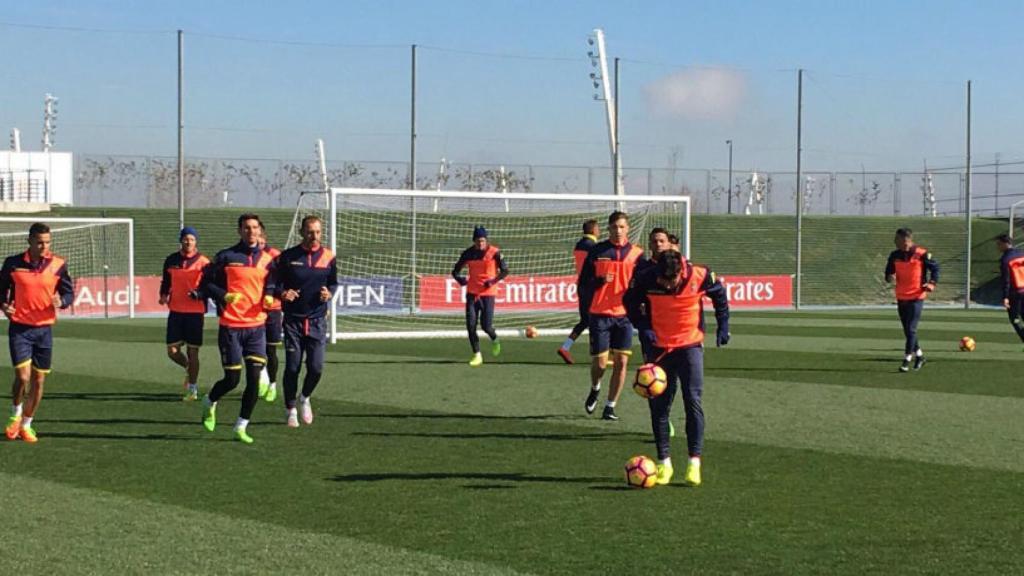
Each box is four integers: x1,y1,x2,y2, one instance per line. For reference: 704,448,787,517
0,472,521,575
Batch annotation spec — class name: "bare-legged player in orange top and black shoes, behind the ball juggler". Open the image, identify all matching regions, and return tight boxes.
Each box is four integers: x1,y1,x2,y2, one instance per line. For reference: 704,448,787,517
580,210,643,420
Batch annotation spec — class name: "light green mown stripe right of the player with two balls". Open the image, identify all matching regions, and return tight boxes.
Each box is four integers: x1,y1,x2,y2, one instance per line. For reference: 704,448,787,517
703,378,1024,472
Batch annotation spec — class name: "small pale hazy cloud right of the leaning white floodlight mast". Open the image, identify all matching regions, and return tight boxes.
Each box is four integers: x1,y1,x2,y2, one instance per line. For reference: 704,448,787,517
644,69,746,120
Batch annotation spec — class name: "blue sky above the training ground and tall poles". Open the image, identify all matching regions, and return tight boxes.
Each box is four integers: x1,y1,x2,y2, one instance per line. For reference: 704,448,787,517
0,0,1024,170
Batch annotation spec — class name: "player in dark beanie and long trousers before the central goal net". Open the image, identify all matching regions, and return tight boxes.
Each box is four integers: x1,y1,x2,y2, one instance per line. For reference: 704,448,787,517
452,225,509,366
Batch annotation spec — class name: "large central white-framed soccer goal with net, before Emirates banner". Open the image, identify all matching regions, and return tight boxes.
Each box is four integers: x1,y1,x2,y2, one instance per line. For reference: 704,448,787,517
289,189,690,341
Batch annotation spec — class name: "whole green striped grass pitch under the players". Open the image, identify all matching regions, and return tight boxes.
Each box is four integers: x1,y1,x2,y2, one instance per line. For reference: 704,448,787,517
0,307,1024,575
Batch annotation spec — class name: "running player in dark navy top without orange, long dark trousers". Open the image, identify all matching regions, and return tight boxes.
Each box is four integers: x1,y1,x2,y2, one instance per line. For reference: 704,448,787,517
275,216,338,428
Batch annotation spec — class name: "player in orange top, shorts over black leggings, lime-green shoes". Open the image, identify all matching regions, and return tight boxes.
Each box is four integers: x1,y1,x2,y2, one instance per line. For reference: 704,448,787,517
195,213,273,444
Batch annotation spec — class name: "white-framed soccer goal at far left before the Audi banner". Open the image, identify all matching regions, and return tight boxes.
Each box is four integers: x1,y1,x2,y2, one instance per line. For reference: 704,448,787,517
0,214,138,318
